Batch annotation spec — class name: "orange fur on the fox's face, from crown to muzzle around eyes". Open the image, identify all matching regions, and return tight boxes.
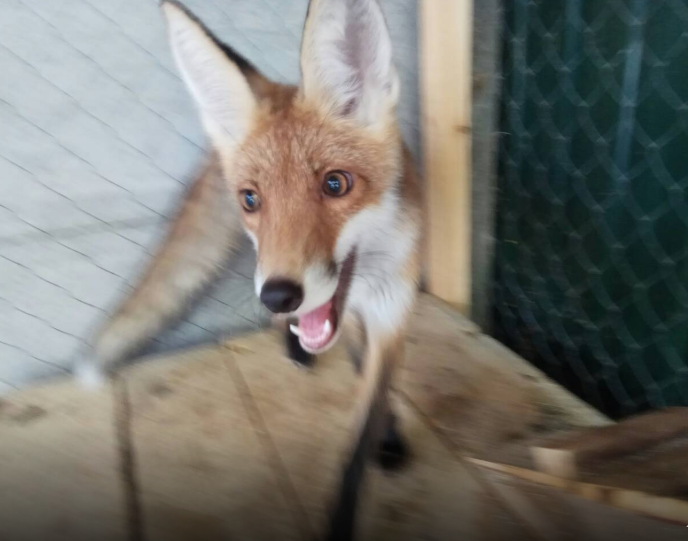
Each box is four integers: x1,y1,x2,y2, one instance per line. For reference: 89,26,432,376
226,94,411,279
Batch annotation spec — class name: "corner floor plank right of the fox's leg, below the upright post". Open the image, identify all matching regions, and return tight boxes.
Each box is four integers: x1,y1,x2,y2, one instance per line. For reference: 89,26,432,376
398,295,609,462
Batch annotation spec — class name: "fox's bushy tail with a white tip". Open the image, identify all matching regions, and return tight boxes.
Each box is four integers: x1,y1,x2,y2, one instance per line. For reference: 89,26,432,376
77,153,241,383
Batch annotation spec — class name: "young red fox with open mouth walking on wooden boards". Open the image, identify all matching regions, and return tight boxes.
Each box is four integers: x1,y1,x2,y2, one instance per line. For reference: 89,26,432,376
79,0,423,541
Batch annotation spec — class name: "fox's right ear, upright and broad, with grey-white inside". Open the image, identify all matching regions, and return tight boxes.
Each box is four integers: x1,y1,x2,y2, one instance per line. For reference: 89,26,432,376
301,0,399,125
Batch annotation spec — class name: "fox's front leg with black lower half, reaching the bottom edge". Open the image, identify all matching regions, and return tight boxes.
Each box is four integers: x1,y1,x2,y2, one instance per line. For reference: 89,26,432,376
325,334,403,541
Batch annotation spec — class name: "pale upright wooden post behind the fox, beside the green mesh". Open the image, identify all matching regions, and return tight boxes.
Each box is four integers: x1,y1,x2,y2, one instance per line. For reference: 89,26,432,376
419,0,473,314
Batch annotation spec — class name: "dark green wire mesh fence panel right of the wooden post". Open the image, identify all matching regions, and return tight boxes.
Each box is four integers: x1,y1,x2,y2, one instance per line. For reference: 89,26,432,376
493,0,688,417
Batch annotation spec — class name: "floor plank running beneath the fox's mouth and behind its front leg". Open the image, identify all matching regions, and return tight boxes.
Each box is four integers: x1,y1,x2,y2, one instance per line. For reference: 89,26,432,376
228,333,528,541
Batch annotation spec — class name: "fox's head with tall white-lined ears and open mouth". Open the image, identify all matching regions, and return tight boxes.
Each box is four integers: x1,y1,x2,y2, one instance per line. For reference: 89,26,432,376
162,0,403,352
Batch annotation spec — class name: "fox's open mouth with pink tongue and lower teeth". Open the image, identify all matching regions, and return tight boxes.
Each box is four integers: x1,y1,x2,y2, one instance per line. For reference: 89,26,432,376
289,251,356,353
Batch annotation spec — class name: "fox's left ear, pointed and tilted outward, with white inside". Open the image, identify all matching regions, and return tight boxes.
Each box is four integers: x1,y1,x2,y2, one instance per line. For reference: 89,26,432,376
161,1,256,148
